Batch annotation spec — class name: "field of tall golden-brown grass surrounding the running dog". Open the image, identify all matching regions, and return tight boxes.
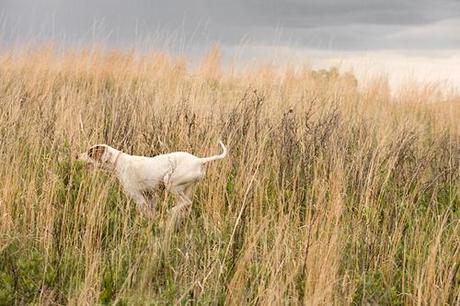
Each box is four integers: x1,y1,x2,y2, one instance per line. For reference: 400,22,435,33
0,47,460,305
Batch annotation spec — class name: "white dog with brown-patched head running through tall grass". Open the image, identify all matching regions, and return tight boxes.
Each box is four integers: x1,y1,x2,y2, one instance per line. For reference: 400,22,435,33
78,142,227,217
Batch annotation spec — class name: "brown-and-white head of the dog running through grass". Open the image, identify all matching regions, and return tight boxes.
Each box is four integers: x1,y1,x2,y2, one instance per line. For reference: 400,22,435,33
77,144,117,170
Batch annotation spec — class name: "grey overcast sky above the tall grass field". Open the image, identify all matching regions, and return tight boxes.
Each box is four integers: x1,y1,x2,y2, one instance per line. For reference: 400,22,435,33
0,0,460,86
